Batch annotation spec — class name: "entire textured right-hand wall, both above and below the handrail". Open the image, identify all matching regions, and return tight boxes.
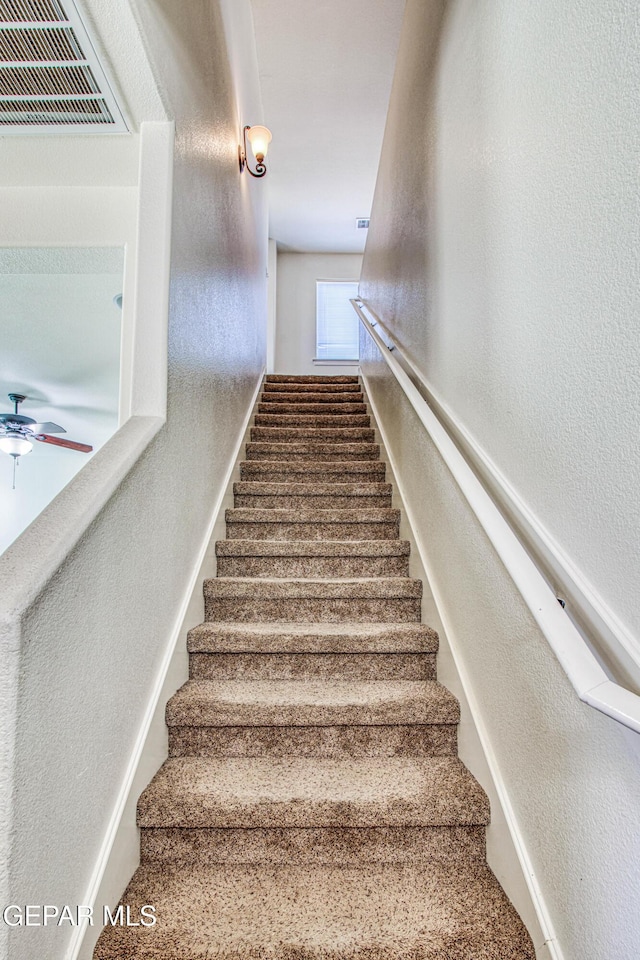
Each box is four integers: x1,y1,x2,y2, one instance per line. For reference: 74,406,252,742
361,0,640,960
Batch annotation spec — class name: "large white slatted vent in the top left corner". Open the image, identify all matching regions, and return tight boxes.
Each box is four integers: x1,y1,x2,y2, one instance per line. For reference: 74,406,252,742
0,0,127,136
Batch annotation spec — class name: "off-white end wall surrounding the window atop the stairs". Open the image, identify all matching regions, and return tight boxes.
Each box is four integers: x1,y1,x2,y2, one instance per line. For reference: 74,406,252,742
275,253,362,376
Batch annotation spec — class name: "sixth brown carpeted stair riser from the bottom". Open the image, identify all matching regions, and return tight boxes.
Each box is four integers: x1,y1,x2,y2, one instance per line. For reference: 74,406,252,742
222,520,400,540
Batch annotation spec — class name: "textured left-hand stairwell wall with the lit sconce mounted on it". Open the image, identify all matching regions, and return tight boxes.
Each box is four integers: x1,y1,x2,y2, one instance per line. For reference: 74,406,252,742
3,0,266,960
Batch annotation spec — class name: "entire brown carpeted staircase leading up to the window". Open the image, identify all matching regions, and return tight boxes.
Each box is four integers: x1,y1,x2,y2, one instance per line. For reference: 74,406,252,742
94,376,534,960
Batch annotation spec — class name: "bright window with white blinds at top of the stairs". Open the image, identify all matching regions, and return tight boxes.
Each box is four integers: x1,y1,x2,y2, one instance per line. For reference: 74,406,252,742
316,280,360,361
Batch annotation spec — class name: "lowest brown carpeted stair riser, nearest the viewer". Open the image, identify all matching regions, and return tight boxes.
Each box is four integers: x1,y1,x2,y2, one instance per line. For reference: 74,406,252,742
140,827,485,866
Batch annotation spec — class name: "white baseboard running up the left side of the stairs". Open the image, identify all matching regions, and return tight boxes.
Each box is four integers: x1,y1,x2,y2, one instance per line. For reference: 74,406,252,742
71,369,264,960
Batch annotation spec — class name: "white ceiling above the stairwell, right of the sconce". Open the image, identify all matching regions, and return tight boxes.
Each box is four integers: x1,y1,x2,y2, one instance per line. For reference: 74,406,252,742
248,0,405,253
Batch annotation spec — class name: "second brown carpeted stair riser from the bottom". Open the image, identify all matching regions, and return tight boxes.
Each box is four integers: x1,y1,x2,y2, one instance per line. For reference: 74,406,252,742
169,723,457,759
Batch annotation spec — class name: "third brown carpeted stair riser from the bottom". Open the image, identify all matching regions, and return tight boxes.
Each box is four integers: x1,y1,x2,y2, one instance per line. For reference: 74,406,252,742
189,653,436,680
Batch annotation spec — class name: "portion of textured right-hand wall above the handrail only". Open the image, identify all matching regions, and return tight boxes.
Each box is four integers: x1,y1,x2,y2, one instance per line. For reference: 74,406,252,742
362,0,640,637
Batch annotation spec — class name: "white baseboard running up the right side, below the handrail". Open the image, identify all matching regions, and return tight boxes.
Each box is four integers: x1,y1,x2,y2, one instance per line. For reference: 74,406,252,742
360,369,564,960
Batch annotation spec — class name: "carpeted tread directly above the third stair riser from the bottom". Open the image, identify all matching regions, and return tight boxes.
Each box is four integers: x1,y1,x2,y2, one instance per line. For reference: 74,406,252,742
187,621,438,653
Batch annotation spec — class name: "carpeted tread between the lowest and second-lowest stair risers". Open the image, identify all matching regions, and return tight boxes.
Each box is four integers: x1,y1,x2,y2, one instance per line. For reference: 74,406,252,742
138,757,489,828
